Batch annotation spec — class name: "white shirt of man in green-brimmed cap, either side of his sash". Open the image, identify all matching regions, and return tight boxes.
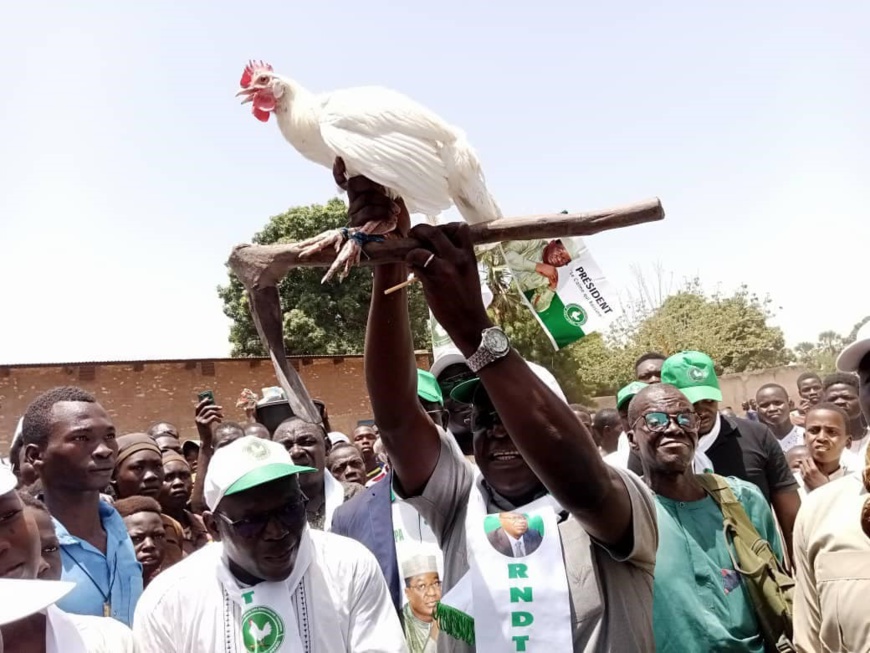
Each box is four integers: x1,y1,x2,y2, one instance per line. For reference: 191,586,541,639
133,529,407,653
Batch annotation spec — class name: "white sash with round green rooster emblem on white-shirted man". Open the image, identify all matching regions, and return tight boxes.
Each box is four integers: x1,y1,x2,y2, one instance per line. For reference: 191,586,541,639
216,526,313,653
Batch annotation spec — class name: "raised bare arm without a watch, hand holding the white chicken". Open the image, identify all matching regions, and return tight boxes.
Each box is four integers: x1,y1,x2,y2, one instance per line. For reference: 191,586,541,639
336,163,441,496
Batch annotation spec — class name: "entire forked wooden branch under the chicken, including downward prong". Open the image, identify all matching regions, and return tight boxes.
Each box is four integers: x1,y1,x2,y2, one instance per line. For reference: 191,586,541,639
229,199,665,423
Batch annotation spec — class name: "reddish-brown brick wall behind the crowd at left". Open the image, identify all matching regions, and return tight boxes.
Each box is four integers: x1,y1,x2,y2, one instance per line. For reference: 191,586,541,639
0,352,429,455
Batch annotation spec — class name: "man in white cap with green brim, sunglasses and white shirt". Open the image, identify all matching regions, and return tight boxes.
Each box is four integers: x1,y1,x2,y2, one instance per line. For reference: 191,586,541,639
133,436,405,653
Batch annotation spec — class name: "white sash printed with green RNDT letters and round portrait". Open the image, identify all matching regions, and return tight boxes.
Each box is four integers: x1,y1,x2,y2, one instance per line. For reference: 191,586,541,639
442,479,573,653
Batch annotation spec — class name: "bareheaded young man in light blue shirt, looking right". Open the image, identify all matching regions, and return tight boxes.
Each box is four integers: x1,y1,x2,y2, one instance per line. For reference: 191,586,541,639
23,387,142,625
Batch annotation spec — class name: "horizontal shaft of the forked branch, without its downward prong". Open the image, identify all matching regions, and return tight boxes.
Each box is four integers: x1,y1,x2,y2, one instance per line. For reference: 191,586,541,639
229,199,665,290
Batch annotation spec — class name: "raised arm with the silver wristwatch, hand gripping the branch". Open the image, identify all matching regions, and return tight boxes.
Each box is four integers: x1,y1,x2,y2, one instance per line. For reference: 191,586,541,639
407,223,632,548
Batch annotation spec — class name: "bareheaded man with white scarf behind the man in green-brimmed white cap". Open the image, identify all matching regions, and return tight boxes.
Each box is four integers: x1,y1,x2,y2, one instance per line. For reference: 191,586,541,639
276,417,365,531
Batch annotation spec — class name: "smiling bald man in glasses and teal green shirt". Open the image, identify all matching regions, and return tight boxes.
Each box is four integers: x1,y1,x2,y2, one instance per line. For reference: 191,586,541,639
628,384,782,653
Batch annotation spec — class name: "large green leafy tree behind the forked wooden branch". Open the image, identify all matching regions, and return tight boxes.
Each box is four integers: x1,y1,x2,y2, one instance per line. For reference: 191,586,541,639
218,198,430,356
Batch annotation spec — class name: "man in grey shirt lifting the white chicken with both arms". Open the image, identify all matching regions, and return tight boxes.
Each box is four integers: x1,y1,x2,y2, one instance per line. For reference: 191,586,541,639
345,169,657,652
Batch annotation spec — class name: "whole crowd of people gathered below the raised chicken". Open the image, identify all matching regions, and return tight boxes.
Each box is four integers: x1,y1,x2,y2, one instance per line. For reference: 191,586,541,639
0,171,870,653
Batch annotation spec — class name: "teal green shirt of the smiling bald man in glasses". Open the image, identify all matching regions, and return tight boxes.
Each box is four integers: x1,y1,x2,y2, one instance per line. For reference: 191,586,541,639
653,477,782,653
